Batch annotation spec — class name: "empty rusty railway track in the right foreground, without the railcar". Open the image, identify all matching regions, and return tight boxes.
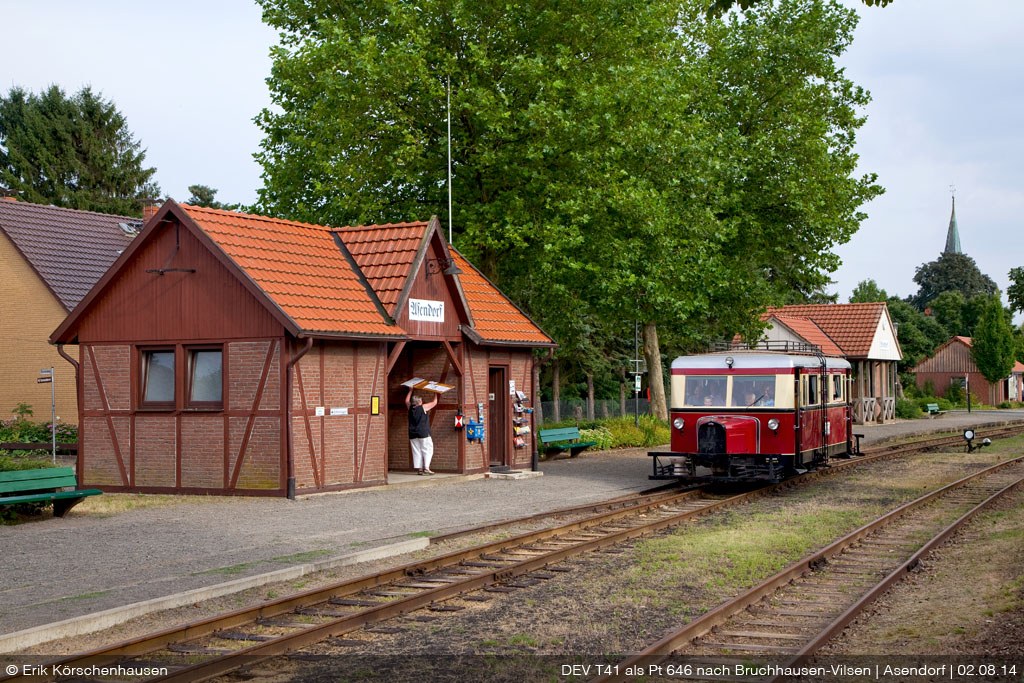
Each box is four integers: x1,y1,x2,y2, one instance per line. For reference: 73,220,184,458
591,450,1024,683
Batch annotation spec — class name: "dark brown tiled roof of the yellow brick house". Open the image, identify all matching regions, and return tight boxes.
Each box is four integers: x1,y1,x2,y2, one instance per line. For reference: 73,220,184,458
0,200,142,311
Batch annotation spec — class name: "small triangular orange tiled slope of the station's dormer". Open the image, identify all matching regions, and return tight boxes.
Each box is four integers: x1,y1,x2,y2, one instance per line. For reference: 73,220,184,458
335,222,428,315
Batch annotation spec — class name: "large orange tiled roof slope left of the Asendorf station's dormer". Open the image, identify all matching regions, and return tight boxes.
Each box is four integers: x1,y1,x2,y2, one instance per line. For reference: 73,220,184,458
181,204,406,336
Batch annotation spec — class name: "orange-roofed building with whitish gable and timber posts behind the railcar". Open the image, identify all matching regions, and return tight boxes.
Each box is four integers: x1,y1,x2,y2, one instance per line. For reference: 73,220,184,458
765,302,903,423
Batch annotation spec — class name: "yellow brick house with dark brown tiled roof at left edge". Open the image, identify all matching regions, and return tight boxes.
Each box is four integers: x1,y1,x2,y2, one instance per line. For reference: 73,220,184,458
0,197,141,422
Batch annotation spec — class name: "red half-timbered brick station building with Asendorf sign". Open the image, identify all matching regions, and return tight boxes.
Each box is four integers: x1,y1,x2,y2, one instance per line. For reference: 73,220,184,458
50,201,554,496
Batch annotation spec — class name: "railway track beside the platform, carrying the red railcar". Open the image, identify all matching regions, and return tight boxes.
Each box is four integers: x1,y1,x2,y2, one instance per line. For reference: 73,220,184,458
9,426,1024,681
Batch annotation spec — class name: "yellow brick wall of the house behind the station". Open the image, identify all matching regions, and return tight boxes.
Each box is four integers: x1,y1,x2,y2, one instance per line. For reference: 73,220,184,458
0,232,78,423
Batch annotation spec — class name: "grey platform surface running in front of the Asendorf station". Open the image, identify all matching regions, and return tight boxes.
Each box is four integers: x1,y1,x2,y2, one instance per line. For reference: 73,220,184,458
0,411,1024,647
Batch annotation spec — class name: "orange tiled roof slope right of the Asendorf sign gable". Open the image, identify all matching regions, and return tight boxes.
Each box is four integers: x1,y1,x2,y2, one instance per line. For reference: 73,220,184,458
450,248,554,345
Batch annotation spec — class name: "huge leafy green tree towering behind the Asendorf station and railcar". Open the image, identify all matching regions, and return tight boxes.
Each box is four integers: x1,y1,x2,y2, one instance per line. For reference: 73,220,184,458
257,0,881,417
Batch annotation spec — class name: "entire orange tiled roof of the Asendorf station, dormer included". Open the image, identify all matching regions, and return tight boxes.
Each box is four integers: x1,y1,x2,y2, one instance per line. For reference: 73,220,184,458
181,205,553,345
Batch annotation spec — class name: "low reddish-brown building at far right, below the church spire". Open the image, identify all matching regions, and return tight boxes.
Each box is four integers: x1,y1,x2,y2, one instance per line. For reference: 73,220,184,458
913,337,1024,405
